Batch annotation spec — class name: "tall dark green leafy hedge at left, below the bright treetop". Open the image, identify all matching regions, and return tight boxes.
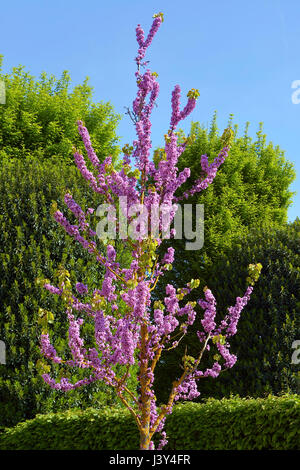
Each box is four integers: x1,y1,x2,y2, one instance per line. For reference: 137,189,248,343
0,158,136,426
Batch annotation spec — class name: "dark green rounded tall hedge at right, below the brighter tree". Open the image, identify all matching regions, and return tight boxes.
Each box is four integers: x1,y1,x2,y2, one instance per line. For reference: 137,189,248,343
156,220,300,400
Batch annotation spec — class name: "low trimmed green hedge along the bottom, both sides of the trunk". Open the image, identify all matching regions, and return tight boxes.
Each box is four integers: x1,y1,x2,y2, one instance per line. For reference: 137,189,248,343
0,395,300,450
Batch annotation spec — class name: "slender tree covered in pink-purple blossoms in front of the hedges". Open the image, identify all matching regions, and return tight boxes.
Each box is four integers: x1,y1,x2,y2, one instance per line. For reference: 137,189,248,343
39,13,261,449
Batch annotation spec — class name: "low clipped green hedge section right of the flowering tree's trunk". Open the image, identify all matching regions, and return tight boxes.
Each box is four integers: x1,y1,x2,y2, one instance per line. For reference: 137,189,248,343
166,395,300,450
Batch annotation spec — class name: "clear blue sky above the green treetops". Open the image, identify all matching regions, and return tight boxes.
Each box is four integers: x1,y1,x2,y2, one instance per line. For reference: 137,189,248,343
0,0,300,220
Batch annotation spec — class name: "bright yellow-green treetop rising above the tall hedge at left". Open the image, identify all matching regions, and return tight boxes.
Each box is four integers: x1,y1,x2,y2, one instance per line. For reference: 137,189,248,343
0,56,120,163
